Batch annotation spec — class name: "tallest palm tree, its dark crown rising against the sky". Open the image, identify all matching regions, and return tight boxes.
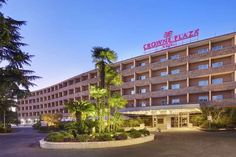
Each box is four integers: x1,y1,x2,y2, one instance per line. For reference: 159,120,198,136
91,47,117,88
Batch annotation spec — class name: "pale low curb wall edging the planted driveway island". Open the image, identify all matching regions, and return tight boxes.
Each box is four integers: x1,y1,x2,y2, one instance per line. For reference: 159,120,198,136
39,134,154,149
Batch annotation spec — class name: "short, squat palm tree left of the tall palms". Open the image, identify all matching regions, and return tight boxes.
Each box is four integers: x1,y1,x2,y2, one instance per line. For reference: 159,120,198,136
66,101,95,122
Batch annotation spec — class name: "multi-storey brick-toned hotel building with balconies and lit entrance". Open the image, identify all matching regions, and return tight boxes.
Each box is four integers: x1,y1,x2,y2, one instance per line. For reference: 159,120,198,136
18,33,236,129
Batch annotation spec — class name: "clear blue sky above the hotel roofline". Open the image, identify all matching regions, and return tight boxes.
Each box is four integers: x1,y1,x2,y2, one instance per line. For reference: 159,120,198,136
0,0,236,90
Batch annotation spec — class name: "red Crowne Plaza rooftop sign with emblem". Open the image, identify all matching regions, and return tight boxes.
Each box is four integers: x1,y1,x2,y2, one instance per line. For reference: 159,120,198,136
143,29,199,51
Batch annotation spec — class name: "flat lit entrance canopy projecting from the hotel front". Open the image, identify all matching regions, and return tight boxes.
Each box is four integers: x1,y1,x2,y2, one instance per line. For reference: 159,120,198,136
120,104,201,115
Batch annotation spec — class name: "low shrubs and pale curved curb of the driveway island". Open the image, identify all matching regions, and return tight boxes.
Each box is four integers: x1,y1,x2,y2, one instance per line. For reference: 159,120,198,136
40,129,154,149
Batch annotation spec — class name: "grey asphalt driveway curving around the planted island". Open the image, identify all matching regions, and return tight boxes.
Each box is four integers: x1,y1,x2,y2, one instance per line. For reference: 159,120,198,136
0,128,236,157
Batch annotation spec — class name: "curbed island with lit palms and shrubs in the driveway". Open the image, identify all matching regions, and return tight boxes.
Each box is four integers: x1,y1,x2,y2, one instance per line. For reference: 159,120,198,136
35,47,154,149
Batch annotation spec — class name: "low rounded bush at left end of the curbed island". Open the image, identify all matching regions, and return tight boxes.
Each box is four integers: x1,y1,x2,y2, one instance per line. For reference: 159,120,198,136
46,132,73,142
